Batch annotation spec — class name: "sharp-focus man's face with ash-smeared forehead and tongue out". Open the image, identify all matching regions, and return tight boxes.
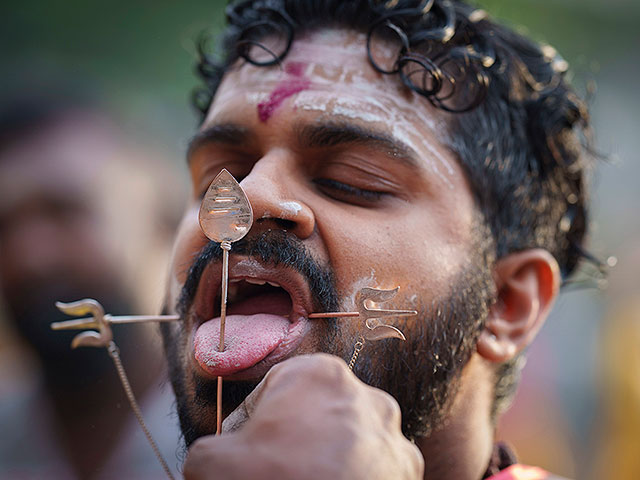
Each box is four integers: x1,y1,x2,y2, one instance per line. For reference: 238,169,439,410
165,30,490,442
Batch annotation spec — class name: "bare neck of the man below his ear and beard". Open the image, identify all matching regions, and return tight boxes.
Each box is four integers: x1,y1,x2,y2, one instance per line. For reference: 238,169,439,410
416,355,494,480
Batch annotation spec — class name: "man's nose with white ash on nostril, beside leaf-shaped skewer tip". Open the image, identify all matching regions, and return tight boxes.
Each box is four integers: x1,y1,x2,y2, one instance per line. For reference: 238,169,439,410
240,154,315,240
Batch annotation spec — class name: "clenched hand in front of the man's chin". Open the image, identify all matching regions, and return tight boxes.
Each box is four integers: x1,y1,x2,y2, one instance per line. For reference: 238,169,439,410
184,354,424,480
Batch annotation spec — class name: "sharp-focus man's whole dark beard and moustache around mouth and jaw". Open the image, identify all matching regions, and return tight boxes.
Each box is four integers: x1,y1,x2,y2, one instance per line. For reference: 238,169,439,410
161,231,495,447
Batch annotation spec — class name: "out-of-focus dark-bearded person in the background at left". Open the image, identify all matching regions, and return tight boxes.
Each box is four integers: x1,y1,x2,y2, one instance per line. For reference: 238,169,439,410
0,90,178,479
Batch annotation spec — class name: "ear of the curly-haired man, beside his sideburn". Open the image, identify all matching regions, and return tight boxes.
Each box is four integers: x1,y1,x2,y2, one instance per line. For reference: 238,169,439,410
477,249,560,363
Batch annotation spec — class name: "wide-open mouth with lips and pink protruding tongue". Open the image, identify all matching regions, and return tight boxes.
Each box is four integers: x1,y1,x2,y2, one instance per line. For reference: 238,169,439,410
193,260,311,376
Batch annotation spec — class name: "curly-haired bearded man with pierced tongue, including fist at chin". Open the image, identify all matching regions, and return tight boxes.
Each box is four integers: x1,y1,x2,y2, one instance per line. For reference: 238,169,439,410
163,0,588,479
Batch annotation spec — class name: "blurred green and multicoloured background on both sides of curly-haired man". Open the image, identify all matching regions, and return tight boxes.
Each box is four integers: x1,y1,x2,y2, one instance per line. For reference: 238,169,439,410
0,0,640,479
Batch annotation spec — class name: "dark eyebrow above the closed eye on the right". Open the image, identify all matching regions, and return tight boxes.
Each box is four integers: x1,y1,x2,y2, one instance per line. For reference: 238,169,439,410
296,123,419,168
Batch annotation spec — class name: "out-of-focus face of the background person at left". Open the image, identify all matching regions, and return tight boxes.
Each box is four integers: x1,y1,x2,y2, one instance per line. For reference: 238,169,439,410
0,120,129,364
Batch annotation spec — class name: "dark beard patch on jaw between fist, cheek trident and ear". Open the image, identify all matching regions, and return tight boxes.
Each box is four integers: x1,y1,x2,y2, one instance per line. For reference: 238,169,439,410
354,262,495,440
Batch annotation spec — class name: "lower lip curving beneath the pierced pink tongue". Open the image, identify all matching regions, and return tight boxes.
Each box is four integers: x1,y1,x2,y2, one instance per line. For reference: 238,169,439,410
192,314,309,380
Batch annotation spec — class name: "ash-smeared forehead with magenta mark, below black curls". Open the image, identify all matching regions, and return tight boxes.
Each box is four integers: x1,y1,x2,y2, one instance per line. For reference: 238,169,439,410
203,29,464,189
